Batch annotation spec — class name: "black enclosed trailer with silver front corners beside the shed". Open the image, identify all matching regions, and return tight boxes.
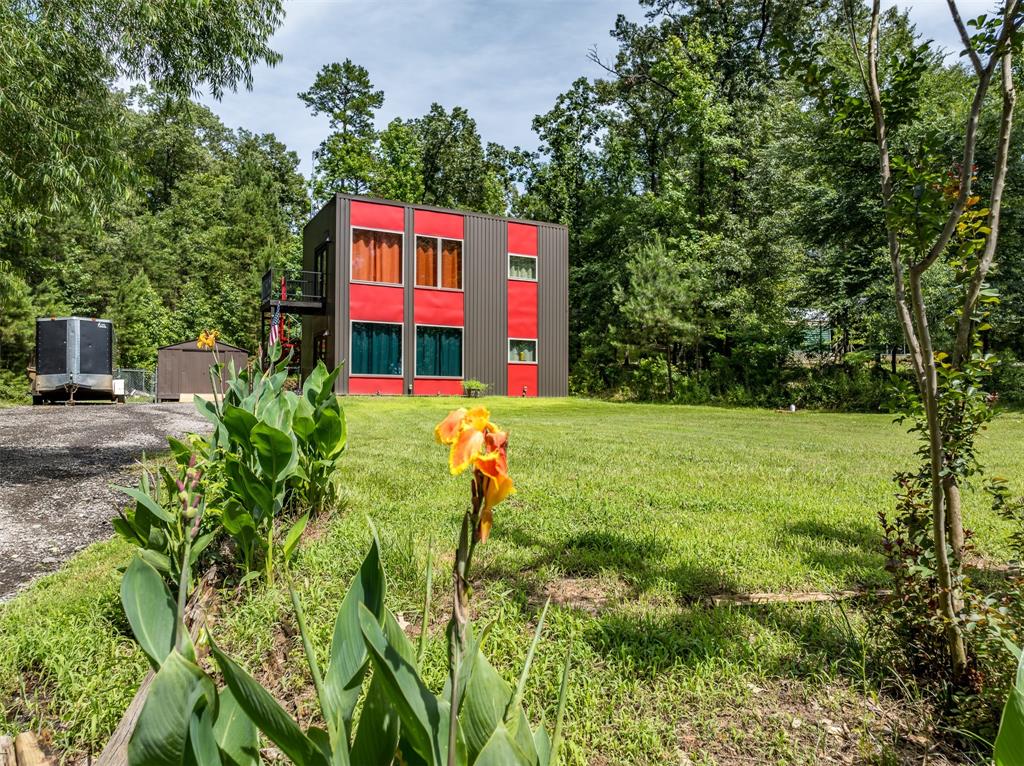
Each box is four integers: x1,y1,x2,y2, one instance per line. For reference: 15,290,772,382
32,316,117,405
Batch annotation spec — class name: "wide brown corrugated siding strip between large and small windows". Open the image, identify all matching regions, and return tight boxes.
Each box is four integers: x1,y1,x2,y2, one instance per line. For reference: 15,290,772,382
463,213,508,395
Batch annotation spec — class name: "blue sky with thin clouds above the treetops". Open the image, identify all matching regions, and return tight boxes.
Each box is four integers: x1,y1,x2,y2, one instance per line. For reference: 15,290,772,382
203,0,994,175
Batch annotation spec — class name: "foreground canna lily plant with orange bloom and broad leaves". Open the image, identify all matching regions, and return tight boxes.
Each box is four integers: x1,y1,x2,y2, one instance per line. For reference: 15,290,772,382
122,409,569,766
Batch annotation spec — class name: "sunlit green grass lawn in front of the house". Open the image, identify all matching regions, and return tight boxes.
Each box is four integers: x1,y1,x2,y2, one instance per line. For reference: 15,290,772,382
0,398,1024,764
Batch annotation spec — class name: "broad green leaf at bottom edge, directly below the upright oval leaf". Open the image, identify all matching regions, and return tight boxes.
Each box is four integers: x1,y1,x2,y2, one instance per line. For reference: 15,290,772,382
128,651,217,766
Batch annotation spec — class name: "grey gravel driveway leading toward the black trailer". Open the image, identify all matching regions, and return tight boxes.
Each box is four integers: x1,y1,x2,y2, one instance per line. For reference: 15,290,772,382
0,403,209,601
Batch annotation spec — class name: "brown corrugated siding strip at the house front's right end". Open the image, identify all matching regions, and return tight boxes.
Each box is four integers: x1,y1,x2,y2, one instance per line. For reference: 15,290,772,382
537,225,569,396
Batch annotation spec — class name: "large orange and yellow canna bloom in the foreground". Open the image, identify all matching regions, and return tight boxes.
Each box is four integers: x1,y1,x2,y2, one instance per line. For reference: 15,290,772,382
434,407,515,543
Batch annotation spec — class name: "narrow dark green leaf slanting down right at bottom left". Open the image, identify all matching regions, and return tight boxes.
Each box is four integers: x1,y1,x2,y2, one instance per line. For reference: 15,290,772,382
210,639,329,766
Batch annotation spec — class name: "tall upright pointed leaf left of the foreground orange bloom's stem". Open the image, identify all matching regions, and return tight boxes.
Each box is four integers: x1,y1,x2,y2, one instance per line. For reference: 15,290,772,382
324,535,386,731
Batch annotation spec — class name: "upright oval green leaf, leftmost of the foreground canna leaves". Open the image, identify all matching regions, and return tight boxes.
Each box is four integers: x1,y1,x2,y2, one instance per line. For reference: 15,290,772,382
121,556,178,670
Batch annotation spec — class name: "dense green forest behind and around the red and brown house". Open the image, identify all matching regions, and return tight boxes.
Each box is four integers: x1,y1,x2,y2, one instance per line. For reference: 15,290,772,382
0,0,1024,409
